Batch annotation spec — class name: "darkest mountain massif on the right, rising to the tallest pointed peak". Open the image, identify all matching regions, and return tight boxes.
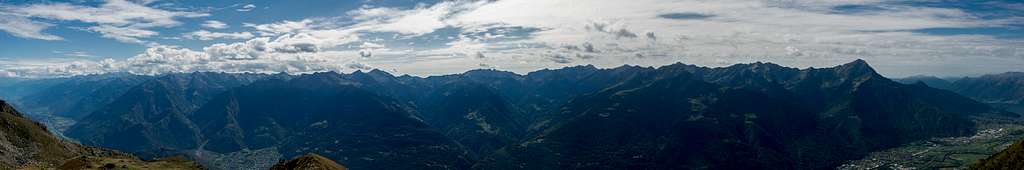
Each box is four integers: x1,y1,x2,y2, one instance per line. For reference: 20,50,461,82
474,59,1012,169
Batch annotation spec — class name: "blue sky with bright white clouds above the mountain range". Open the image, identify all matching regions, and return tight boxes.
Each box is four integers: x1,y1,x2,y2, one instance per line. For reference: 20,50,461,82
0,0,1024,78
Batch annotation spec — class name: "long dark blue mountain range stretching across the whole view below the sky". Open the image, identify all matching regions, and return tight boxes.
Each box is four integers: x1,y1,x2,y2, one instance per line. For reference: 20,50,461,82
0,59,1021,169
